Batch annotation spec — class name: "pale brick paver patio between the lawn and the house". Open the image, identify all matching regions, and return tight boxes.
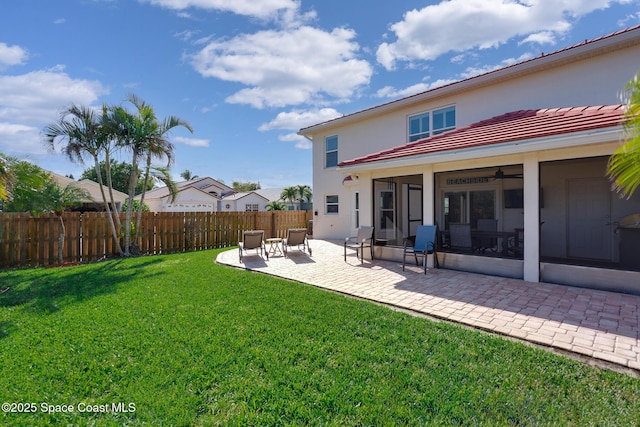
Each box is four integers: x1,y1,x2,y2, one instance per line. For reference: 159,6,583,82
217,240,640,374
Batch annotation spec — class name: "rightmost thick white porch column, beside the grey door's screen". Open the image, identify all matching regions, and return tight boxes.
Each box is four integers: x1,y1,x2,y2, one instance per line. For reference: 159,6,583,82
523,153,540,282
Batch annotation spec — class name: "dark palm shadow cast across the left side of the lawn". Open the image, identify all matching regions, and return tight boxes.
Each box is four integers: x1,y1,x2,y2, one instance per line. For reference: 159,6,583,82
0,258,162,316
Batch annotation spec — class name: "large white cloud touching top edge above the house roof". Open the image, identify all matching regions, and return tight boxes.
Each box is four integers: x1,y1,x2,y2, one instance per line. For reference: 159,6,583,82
377,0,629,70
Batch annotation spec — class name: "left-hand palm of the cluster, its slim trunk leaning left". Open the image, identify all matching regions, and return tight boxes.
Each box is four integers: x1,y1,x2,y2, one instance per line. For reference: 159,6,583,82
44,105,123,255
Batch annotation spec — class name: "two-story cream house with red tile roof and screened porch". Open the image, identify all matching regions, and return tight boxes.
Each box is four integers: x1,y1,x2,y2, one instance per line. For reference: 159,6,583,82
299,27,640,293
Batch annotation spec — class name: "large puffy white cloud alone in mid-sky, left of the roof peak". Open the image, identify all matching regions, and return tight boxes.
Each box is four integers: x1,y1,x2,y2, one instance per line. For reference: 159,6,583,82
191,26,372,108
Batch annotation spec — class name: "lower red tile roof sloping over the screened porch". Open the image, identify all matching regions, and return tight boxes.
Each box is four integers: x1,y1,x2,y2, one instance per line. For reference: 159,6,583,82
338,105,625,166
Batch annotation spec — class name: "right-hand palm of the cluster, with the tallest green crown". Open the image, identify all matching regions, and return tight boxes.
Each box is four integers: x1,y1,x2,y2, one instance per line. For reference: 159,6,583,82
111,95,193,256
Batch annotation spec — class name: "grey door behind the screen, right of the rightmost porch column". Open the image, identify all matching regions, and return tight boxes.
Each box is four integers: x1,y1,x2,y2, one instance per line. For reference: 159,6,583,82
567,178,613,261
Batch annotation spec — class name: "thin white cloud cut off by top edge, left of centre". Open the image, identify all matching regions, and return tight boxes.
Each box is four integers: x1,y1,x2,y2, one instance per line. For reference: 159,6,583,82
140,0,300,19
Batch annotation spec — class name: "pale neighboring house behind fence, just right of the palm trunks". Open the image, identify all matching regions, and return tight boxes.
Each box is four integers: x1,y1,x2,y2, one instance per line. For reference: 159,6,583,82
135,177,233,212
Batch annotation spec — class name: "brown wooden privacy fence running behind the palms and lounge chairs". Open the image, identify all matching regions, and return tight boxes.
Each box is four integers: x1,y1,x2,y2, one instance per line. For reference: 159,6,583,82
0,211,311,268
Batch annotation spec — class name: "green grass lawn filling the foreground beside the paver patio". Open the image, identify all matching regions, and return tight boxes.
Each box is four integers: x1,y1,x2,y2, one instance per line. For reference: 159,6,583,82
0,251,640,426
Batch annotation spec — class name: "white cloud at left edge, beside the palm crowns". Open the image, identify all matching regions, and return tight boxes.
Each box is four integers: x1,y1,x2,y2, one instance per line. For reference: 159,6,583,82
0,66,107,155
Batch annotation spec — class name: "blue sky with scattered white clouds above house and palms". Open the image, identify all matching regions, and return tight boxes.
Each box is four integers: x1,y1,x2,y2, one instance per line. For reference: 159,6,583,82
0,0,640,188
